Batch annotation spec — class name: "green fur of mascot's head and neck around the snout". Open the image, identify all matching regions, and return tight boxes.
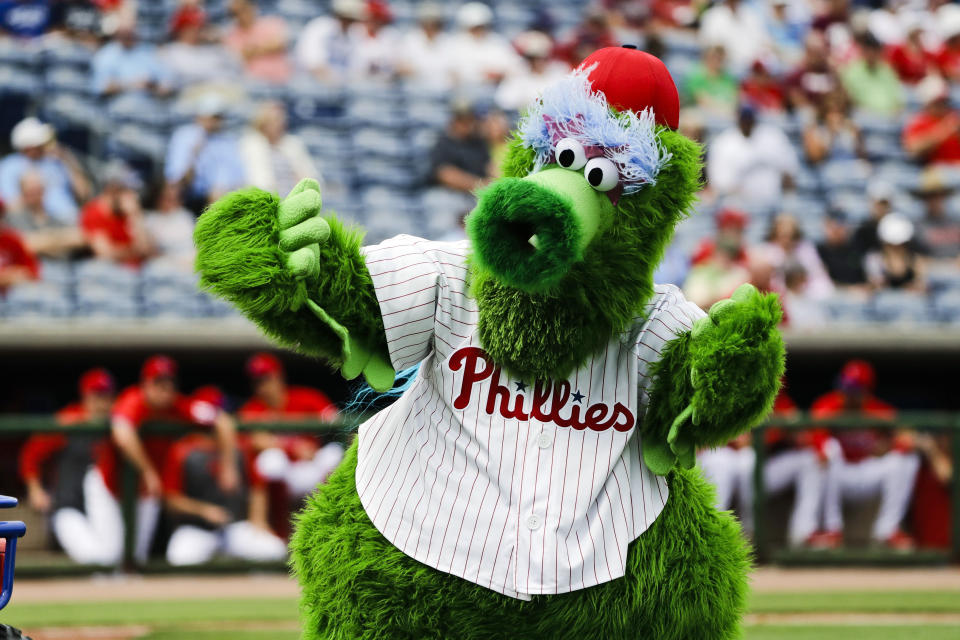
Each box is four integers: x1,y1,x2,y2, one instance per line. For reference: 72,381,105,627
473,129,701,379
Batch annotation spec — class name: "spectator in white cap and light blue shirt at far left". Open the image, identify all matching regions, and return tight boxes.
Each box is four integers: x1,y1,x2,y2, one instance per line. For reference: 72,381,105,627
0,117,90,224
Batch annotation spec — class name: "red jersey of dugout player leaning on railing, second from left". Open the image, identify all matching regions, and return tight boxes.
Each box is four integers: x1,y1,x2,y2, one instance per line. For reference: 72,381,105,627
97,385,220,493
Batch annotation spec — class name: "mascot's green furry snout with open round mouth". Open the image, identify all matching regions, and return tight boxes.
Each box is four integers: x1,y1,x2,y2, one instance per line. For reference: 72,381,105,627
467,166,613,292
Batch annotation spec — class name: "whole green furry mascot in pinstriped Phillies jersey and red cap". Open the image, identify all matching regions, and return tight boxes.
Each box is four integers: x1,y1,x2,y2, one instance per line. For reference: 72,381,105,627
196,47,783,640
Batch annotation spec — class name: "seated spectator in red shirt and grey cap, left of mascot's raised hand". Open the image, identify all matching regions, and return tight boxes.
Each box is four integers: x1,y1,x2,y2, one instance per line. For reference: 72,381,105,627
80,160,153,266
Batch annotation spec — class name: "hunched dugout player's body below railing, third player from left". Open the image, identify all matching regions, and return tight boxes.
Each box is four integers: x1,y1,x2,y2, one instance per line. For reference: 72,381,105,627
163,434,287,566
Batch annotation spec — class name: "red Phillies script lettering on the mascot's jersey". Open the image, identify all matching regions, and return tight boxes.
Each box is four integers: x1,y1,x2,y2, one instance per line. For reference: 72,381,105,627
449,347,635,431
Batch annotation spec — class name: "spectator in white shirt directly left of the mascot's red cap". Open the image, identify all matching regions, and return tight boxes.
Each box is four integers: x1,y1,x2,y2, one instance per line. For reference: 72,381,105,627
494,31,570,111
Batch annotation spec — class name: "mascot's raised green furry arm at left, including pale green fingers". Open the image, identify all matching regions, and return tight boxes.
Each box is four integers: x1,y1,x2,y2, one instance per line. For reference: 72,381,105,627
194,180,394,390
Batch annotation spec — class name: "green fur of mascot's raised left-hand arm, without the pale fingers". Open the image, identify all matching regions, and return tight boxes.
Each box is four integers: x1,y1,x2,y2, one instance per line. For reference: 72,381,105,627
194,187,386,366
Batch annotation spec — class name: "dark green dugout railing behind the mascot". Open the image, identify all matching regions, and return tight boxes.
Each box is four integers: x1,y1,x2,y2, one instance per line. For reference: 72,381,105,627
0,412,960,576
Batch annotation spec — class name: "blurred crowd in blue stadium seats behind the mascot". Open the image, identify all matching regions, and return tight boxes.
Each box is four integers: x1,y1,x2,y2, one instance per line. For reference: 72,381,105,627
0,0,960,327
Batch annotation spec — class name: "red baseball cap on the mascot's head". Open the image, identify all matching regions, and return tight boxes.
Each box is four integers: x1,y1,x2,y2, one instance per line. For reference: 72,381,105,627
578,45,680,129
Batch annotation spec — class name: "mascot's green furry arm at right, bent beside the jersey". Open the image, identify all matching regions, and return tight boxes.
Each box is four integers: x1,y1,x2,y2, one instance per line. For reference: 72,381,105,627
641,284,784,475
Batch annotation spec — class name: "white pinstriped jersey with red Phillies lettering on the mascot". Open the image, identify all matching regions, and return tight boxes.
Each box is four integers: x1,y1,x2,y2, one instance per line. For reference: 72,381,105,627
356,236,704,599
